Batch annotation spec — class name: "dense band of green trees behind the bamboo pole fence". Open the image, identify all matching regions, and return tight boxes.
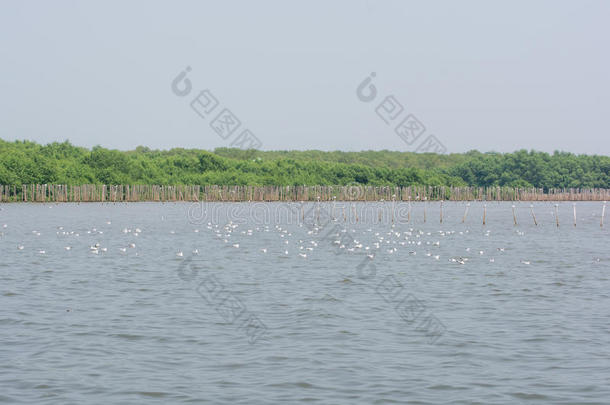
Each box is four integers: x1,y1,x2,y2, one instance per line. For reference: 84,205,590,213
0,139,610,190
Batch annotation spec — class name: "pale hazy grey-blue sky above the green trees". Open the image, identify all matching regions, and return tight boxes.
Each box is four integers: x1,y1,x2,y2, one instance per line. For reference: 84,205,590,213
0,0,610,155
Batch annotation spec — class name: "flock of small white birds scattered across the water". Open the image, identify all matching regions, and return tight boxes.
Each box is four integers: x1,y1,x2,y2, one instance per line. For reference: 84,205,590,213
2,215,531,265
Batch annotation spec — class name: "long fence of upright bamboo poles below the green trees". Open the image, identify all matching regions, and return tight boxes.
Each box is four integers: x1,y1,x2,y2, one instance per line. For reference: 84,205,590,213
0,184,610,202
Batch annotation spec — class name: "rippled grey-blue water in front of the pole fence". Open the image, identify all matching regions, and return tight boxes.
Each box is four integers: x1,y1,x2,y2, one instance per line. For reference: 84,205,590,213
0,203,610,404
